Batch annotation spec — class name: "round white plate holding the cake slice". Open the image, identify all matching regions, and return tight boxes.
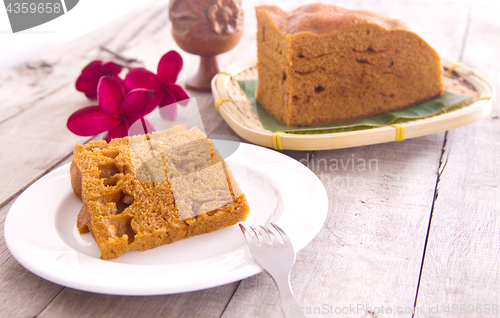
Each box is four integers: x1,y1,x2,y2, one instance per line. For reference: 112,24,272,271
4,144,328,295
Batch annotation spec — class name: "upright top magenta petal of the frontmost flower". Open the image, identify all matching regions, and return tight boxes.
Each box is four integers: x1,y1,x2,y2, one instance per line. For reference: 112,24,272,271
97,76,125,116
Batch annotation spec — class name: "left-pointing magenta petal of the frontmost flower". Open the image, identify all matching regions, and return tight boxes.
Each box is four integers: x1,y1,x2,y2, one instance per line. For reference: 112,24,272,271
66,106,120,136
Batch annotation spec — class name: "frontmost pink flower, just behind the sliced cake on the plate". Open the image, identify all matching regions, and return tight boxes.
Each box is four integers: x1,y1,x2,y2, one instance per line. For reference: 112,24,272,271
67,76,156,142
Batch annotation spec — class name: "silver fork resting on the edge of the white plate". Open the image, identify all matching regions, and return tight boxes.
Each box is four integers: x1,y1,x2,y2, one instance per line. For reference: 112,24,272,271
239,223,306,318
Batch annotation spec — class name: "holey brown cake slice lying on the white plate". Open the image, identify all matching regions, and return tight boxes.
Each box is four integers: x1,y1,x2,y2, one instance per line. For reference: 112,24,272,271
71,126,249,259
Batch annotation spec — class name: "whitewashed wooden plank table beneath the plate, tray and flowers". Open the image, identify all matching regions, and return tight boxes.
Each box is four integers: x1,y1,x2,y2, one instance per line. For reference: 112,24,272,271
0,0,500,317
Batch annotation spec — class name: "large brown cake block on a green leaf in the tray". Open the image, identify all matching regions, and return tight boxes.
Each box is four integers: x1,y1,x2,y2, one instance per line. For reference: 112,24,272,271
256,4,443,126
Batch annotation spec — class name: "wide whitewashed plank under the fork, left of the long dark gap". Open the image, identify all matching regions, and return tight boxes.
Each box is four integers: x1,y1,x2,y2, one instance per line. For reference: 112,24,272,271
223,1,468,317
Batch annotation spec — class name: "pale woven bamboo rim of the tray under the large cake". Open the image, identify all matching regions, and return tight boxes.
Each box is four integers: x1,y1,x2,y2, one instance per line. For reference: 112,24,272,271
211,57,495,151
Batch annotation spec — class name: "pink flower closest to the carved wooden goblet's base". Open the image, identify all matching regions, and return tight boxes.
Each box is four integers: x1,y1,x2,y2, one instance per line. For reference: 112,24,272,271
125,51,190,120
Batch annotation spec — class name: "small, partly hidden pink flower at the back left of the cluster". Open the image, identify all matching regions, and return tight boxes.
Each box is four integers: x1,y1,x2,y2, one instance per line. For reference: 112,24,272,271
75,60,123,99
